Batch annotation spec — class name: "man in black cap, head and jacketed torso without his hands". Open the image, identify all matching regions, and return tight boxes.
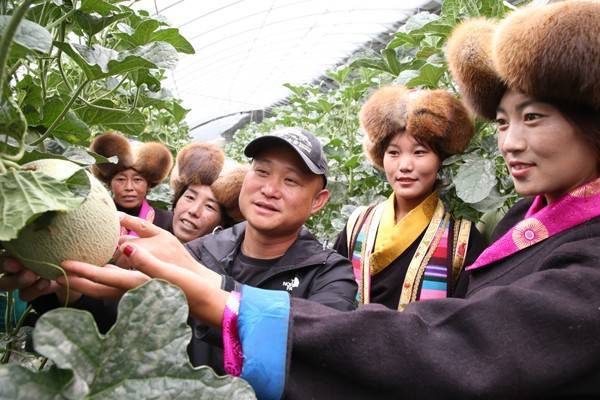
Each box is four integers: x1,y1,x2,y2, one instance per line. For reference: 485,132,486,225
178,128,357,372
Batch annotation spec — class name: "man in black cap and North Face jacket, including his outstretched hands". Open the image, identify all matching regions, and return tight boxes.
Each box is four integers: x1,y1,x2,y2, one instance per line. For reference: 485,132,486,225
16,128,357,373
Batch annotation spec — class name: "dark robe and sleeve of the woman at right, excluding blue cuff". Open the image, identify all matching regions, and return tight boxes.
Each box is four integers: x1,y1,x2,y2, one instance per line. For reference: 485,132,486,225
285,201,600,399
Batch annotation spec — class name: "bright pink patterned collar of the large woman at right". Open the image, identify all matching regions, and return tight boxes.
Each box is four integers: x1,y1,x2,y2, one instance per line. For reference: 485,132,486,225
466,178,600,270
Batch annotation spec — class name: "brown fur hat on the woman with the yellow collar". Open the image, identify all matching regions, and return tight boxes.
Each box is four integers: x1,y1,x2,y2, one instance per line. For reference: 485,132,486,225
360,85,474,169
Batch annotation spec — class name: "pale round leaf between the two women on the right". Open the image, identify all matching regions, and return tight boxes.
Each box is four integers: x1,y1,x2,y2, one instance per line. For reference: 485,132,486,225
453,158,496,203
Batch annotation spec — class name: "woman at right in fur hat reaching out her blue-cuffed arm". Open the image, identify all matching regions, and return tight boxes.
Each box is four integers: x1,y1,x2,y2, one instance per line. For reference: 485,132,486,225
35,0,600,399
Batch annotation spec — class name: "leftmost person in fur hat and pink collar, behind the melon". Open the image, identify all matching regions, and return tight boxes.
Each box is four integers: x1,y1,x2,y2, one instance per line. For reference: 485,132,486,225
90,132,173,234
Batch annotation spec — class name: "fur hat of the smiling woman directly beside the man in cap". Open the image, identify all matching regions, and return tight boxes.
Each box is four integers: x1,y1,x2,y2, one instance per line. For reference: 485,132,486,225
171,143,248,221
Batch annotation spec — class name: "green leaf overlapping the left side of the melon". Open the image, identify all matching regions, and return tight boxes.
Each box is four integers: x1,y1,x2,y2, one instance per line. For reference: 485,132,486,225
0,169,90,241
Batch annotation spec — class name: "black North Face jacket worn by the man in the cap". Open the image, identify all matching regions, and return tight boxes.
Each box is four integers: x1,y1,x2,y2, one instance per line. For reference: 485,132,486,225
186,222,357,373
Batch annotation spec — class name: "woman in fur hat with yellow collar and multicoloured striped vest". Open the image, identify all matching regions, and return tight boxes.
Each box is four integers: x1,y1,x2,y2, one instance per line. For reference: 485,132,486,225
334,86,485,310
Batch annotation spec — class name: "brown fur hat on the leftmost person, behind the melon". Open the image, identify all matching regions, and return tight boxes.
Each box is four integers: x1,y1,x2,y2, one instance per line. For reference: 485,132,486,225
90,132,173,187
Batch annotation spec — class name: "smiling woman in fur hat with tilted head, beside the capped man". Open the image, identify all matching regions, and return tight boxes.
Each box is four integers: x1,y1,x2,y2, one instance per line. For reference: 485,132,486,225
171,143,248,242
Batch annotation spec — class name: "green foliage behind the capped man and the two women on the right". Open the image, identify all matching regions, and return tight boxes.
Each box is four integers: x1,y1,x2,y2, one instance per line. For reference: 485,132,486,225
226,0,517,242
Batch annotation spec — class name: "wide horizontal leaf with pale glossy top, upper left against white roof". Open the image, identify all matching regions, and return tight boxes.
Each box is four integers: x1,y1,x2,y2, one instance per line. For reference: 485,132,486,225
54,42,178,80
